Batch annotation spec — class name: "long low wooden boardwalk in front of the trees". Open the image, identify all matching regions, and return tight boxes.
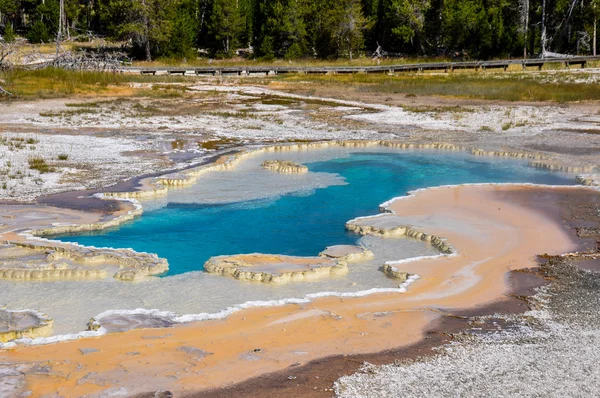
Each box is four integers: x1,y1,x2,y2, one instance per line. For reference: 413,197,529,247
124,56,600,76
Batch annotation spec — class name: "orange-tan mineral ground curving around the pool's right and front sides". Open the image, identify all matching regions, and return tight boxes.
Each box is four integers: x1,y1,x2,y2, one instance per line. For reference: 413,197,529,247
0,186,584,396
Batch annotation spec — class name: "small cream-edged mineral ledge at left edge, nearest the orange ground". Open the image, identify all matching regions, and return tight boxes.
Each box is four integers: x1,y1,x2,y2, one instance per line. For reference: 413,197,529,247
0,309,52,343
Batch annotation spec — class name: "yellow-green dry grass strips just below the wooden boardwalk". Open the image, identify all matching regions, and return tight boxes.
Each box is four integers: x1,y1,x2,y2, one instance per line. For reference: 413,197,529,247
0,61,600,103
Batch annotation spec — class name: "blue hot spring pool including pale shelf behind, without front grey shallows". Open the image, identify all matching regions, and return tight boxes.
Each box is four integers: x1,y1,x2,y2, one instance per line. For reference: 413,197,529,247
59,148,574,275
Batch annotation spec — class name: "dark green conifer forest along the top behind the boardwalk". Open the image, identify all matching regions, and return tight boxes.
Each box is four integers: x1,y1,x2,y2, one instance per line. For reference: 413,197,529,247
7,0,600,60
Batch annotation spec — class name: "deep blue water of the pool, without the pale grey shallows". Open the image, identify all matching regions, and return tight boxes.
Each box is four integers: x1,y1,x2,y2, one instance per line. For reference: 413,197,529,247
60,152,574,275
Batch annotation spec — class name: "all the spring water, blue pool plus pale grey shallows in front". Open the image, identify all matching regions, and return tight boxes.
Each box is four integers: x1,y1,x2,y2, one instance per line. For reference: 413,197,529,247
0,148,573,334
